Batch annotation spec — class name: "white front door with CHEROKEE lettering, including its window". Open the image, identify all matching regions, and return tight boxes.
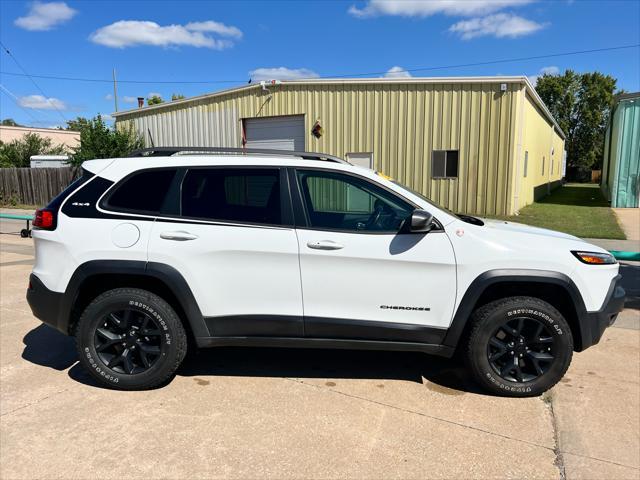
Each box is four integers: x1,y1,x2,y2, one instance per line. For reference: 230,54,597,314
290,168,456,343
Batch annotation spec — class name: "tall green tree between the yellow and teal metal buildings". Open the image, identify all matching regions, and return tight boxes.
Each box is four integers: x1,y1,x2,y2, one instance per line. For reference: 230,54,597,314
536,70,616,180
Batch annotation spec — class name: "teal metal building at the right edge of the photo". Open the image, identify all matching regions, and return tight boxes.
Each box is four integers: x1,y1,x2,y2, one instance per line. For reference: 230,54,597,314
602,92,640,208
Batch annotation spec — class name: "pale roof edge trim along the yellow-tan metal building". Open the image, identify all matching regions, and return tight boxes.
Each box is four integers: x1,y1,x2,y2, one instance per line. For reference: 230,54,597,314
111,76,565,139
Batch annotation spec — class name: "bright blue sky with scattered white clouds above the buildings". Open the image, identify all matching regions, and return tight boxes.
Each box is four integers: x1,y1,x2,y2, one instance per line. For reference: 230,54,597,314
0,0,640,127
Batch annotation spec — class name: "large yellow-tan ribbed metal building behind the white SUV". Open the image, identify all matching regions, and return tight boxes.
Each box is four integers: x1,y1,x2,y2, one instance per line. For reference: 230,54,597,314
114,77,564,215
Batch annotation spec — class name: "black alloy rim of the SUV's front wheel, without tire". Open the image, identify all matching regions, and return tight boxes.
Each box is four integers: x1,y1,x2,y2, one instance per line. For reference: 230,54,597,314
487,317,555,383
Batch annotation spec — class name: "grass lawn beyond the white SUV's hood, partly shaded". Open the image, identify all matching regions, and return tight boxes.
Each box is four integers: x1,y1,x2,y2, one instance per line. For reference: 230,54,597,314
490,183,626,240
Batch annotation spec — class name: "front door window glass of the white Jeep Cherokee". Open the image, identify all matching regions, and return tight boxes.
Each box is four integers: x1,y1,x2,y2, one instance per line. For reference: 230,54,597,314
296,169,413,232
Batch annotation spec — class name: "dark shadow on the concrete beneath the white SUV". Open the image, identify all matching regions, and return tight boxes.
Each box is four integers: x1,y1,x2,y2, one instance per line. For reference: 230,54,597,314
22,325,480,395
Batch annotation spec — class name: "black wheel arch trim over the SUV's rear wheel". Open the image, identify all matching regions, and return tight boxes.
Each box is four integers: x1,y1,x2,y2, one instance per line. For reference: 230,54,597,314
57,260,209,337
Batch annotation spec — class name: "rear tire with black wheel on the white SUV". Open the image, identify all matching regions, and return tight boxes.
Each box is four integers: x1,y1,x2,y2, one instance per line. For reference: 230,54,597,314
76,288,187,390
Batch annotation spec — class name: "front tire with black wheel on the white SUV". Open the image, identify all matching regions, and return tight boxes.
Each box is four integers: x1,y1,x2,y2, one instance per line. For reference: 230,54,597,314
466,297,573,397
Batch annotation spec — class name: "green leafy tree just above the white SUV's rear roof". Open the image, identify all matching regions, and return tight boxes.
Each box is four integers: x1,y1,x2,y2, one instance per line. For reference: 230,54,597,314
70,115,144,165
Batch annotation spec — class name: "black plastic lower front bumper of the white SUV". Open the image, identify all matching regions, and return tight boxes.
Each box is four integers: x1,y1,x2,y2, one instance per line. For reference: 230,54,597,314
578,275,625,351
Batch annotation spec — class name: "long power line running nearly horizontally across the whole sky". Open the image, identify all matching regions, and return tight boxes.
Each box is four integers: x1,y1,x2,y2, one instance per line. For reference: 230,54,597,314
0,44,640,85
